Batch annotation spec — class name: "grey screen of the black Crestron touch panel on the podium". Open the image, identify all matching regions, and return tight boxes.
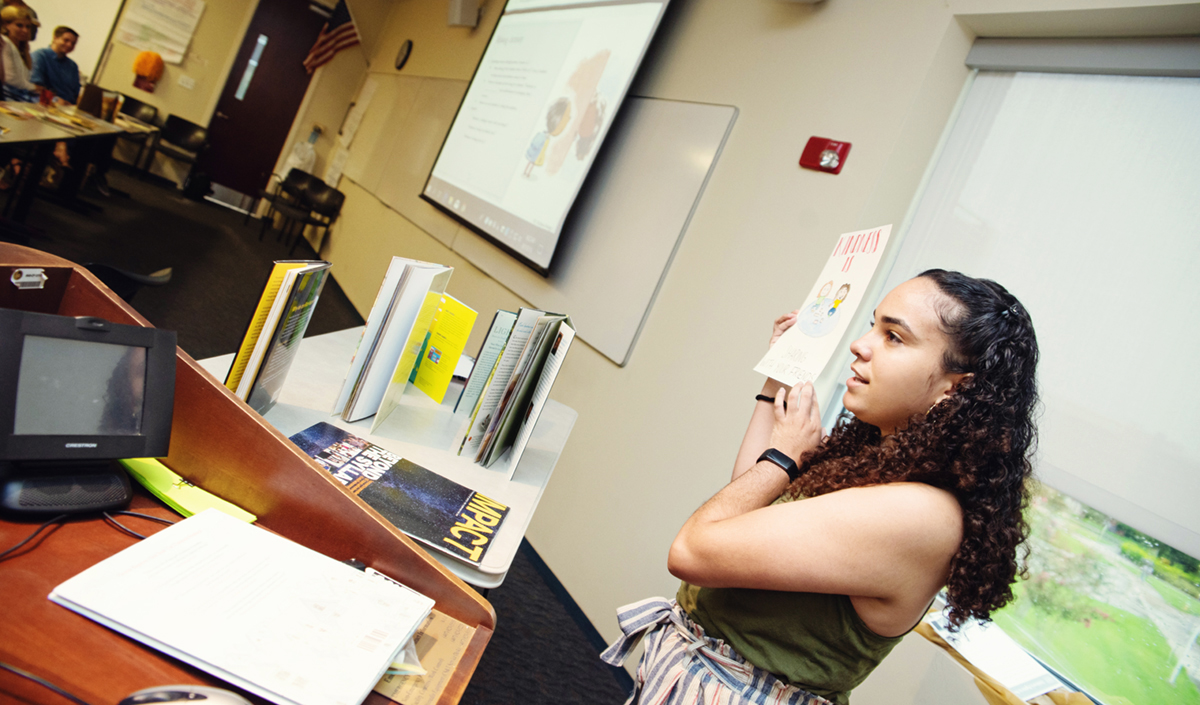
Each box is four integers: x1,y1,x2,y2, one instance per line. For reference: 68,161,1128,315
13,336,146,435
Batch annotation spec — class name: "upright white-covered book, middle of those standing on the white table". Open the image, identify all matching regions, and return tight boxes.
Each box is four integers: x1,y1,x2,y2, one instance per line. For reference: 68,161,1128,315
334,257,454,422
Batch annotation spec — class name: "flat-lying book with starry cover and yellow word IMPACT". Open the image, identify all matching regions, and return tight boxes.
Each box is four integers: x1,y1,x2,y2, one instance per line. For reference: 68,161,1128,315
292,422,509,566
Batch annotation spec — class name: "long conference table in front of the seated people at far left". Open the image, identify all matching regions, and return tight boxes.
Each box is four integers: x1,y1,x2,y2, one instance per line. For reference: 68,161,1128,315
0,102,126,223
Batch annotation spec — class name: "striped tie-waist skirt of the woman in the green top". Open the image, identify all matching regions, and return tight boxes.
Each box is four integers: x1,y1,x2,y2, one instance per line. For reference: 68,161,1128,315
600,597,832,705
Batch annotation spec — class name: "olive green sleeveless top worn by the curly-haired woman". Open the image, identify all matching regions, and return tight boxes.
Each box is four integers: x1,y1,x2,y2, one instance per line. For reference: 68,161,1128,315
676,500,904,705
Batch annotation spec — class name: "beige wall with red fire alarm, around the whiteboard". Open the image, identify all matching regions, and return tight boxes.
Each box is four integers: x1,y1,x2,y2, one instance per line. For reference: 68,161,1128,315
292,0,1200,657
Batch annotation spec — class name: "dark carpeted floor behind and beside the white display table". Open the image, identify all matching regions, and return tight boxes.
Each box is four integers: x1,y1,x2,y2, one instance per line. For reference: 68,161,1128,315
9,169,632,705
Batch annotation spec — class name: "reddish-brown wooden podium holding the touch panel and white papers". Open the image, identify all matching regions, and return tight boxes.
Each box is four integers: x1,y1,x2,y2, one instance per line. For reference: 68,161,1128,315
0,243,496,705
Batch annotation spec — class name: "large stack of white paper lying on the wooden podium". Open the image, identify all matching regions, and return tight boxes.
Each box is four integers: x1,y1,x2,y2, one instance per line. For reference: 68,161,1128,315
49,510,433,705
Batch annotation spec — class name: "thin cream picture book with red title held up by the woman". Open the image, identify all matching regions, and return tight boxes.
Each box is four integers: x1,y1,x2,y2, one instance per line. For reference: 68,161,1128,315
754,225,892,386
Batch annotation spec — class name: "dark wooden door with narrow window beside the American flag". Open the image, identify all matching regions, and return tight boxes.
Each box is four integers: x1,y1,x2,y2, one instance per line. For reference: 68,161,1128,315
197,0,326,195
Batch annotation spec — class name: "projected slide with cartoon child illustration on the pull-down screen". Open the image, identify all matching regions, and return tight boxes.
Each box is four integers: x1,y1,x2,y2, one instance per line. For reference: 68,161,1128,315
422,0,666,271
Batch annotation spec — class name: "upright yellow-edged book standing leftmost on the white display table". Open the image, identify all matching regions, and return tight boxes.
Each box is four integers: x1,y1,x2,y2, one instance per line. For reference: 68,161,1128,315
226,260,330,414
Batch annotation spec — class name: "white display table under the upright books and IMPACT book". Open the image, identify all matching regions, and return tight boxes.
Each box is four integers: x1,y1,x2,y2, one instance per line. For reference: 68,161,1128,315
199,327,577,589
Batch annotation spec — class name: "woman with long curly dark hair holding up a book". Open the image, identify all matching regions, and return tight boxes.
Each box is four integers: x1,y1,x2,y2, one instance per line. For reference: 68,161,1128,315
604,270,1038,705
